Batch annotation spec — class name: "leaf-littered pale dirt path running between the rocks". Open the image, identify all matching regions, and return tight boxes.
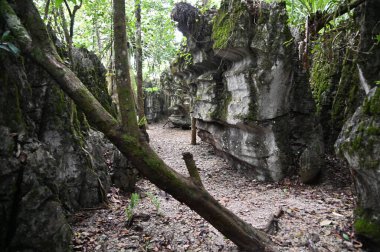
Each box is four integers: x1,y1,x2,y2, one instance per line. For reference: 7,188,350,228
73,124,361,251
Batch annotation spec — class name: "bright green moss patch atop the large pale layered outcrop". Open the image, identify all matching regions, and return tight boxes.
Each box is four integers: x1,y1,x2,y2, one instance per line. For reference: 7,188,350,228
212,0,248,49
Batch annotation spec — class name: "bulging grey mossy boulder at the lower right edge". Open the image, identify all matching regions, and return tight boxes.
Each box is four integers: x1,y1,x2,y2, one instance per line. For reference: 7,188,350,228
335,88,380,246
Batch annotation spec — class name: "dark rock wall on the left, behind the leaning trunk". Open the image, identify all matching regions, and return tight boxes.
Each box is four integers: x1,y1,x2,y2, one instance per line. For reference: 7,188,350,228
0,23,132,251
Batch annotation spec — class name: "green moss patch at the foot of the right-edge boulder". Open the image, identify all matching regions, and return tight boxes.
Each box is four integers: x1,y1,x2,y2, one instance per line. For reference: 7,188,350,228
354,208,380,243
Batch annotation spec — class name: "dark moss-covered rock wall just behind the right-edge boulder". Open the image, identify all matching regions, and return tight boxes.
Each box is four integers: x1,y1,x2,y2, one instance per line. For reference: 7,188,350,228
310,25,364,152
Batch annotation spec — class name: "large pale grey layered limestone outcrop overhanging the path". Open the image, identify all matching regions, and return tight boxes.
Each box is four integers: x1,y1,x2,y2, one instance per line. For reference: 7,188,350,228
172,1,323,182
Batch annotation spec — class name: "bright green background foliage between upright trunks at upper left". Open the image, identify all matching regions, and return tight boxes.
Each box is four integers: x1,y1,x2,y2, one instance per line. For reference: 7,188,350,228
34,0,179,79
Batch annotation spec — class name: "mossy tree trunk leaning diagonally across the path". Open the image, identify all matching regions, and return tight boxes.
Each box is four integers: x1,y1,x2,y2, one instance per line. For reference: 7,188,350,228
0,0,275,251
